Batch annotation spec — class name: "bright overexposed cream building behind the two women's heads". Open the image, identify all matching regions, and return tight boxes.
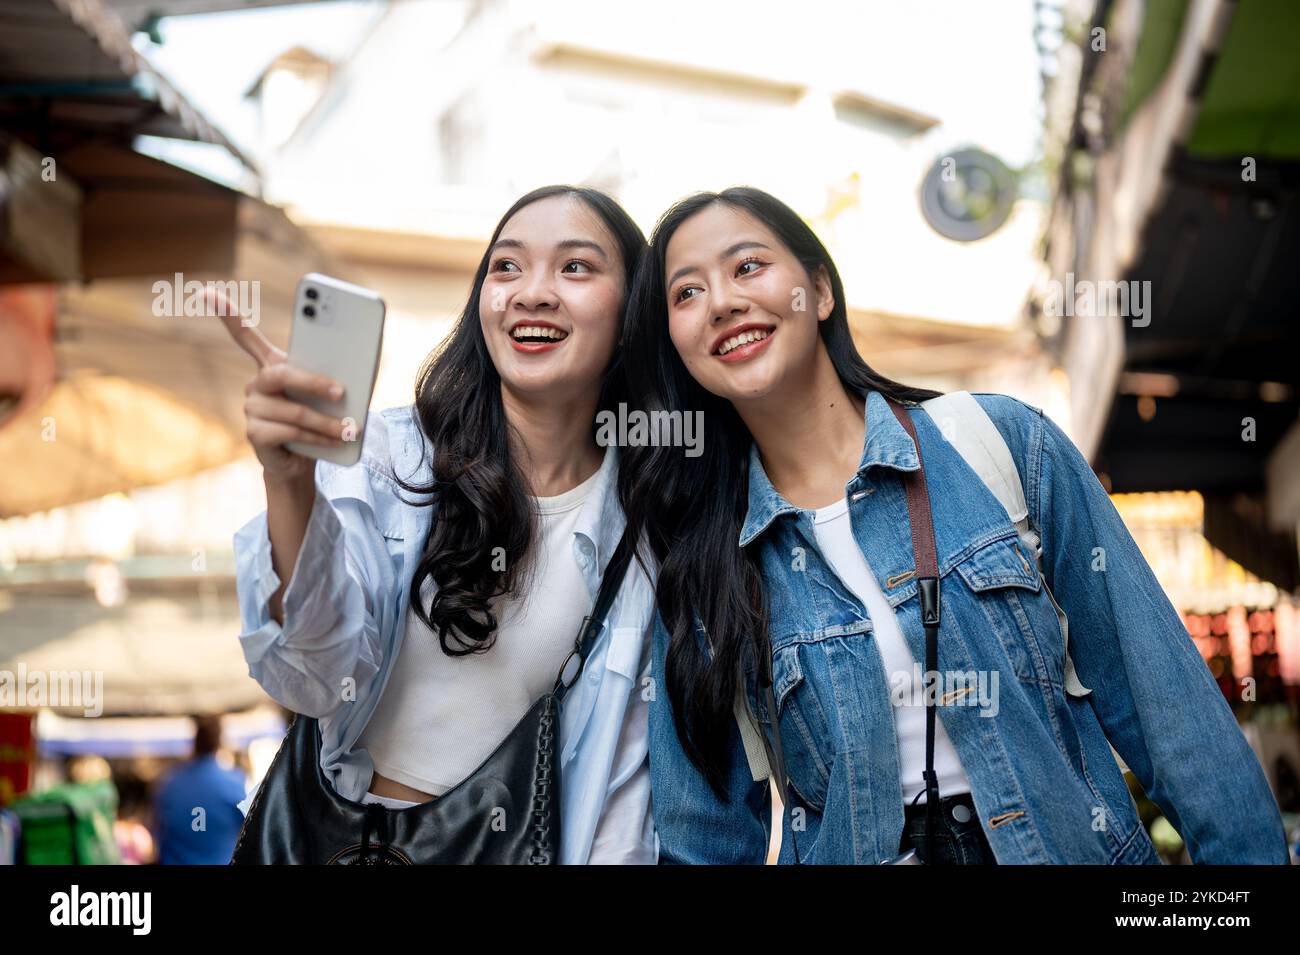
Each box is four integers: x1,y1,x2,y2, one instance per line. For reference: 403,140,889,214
239,0,1063,409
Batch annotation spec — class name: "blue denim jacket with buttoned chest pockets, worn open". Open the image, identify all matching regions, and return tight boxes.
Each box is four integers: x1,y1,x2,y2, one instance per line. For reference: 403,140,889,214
650,392,1287,864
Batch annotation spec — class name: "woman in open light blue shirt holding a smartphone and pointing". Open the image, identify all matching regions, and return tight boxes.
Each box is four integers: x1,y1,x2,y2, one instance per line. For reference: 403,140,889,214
228,186,655,863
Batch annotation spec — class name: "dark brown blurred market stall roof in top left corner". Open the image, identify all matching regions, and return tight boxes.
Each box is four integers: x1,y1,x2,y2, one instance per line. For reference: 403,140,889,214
0,0,255,283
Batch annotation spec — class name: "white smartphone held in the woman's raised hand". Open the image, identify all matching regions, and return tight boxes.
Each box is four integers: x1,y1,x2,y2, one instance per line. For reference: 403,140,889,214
285,272,384,465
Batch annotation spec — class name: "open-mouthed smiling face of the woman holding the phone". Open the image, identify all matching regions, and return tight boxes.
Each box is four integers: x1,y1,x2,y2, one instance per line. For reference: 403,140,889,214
478,196,624,399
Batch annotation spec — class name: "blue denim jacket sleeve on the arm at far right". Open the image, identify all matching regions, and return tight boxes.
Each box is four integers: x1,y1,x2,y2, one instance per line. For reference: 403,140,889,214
1031,413,1287,863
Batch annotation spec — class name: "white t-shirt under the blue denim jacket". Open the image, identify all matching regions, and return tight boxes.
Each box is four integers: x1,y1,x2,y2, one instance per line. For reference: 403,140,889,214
813,500,971,804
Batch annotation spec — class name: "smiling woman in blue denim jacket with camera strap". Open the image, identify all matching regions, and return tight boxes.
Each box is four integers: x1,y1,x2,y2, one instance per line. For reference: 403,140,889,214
621,188,1287,864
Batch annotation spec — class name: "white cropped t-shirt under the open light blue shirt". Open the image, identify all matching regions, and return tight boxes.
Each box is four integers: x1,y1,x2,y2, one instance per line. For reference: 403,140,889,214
359,452,608,808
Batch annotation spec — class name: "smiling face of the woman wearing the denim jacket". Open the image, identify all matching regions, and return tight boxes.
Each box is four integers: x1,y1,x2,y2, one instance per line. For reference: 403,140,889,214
664,203,833,401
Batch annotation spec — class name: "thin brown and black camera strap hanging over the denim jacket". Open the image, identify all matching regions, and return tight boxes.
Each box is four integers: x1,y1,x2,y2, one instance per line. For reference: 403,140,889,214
759,399,939,865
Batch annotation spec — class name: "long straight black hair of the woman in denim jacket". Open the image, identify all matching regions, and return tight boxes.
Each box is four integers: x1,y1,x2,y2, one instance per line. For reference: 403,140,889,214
619,187,939,798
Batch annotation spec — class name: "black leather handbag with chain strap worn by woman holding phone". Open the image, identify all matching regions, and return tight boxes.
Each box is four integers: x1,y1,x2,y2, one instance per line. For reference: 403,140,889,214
230,534,632,865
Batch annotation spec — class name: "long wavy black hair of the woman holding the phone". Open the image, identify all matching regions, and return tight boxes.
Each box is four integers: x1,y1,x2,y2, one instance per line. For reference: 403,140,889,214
398,186,646,656
